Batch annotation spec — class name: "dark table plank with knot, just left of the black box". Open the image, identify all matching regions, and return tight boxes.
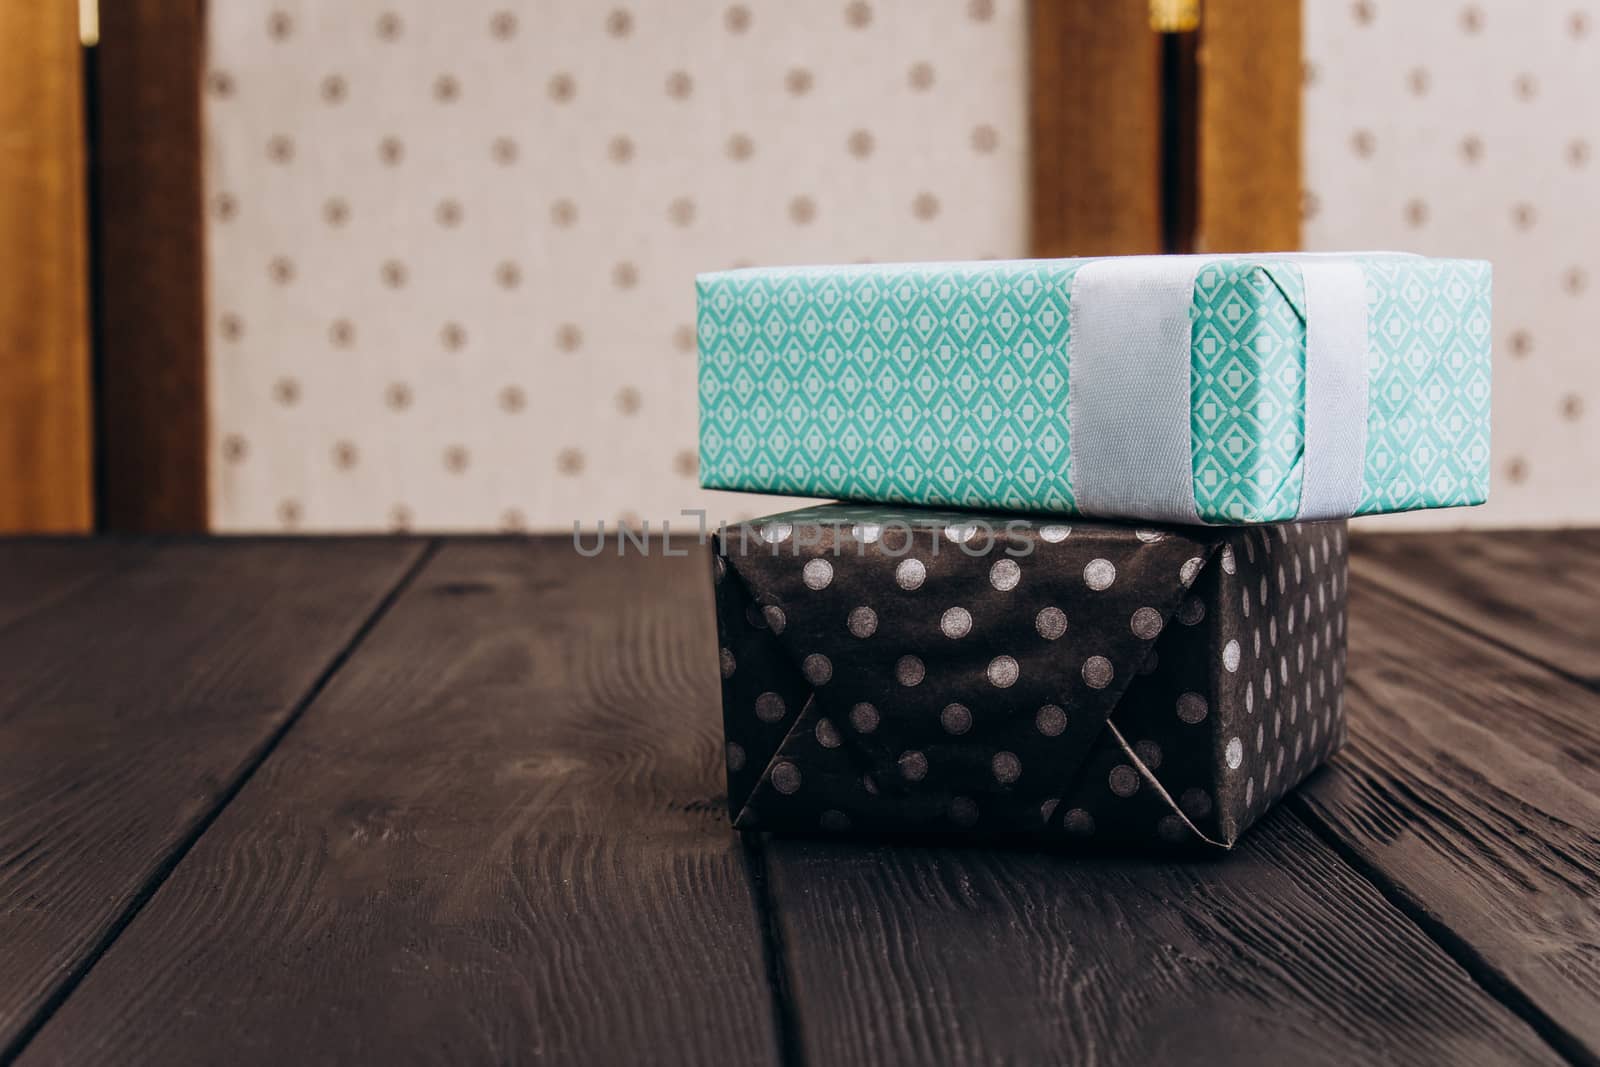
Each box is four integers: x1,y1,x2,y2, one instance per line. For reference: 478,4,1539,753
22,537,778,1064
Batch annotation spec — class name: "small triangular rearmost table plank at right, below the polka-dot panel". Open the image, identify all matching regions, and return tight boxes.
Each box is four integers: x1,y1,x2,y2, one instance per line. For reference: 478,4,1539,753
1350,530,1600,686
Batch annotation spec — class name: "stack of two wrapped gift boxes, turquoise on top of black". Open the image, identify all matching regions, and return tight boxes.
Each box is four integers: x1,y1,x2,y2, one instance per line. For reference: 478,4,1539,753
699,253,1490,848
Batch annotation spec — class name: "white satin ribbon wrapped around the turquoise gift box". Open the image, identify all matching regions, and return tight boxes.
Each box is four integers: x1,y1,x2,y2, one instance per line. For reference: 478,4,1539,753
1067,253,1368,523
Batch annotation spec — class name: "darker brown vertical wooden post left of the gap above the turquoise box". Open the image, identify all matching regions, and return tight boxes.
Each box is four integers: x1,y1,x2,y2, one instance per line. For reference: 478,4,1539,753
1029,0,1162,256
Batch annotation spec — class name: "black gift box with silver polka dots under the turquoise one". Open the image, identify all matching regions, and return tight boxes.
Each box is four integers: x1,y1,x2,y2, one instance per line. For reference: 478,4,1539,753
714,504,1347,848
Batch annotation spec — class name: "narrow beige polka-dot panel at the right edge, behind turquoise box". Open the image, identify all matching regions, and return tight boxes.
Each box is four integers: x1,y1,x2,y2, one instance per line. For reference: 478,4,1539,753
1302,0,1600,528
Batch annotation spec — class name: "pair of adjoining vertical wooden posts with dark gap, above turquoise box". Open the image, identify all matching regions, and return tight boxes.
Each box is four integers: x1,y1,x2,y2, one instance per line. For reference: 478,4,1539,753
1029,0,1301,256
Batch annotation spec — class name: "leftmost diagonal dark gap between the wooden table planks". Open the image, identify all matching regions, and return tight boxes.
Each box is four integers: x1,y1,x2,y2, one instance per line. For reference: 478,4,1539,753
0,537,440,1067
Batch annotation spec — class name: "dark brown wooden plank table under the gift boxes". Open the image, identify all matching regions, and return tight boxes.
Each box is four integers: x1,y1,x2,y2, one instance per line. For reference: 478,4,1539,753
0,533,1600,1067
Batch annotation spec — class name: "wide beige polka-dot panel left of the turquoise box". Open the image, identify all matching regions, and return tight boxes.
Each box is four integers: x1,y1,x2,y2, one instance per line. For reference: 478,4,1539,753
203,0,1027,531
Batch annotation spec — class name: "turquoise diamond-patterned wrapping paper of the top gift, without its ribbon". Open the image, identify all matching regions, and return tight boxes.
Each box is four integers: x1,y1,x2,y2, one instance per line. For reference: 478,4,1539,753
698,254,1491,523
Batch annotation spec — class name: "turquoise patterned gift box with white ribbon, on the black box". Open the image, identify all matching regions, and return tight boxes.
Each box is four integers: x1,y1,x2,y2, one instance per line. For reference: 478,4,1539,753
698,253,1491,525
